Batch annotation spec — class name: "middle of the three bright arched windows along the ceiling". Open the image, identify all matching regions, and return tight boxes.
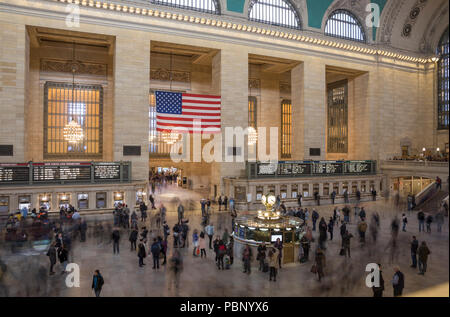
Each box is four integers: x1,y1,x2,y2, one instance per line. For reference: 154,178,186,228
248,0,301,29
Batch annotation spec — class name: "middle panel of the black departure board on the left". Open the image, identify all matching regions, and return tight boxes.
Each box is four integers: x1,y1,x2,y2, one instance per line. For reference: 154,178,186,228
33,163,91,182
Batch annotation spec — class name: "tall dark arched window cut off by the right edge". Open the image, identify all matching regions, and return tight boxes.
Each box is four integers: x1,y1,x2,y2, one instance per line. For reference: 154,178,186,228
437,28,449,130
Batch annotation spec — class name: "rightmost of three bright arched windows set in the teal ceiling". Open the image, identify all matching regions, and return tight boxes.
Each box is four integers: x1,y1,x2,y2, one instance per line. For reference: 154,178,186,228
325,10,366,42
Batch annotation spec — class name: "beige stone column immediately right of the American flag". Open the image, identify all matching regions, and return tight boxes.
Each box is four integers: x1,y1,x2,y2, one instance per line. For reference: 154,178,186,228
211,45,248,197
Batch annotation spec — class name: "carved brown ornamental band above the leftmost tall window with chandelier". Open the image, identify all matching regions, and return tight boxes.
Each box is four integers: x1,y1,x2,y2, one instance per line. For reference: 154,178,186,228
40,59,108,77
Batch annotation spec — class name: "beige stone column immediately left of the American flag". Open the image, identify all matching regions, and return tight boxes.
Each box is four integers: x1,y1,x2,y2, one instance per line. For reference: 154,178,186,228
113,30,150,181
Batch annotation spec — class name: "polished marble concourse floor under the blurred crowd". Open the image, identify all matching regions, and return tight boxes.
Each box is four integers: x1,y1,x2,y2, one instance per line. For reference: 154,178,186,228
0,188,449,297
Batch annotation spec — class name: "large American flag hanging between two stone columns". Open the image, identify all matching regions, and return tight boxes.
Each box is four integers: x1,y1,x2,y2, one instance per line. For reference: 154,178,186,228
155,91,221,133
